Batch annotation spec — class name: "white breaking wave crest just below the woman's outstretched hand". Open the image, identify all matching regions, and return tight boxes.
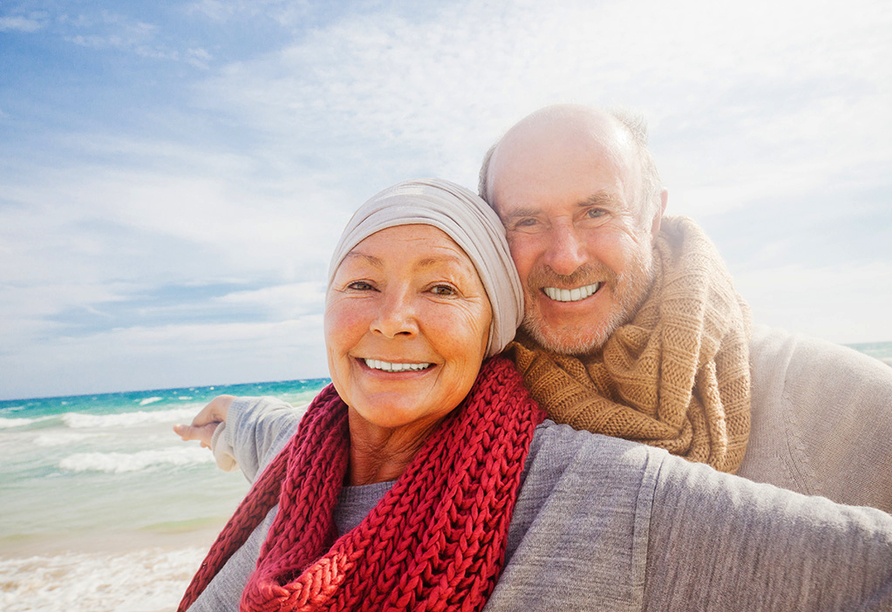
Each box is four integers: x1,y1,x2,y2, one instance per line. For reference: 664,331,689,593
59,446,214,474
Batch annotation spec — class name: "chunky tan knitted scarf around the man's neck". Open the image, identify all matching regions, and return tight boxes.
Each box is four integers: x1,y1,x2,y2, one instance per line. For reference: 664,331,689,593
507,217,750,473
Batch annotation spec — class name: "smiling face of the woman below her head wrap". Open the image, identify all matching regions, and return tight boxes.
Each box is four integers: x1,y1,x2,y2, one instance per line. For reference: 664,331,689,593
325,225,492,436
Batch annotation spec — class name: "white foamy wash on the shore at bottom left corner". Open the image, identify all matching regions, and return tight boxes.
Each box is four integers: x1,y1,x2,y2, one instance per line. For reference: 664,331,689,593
0,548,205,612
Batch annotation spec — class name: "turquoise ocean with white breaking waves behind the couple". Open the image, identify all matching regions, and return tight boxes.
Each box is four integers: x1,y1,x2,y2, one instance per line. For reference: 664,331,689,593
0,342,892,612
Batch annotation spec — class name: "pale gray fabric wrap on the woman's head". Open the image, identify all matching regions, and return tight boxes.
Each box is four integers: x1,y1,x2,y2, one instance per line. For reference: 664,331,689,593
328,179,523,357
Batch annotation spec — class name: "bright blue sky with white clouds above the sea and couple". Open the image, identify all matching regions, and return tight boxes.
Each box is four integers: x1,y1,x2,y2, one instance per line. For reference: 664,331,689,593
0,0,892,399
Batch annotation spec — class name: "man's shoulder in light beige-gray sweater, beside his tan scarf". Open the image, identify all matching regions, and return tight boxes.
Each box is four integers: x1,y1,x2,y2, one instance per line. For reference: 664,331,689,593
738,327,892,512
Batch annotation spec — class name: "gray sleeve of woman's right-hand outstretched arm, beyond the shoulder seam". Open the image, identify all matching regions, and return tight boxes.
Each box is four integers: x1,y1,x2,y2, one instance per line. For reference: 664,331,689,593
645,448,892,611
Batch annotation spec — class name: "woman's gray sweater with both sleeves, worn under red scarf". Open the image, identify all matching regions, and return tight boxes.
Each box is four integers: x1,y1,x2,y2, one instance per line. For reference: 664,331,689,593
191,398,892,611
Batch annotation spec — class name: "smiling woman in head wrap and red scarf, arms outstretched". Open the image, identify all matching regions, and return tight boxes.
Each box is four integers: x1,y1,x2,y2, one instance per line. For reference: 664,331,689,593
178,180,892,611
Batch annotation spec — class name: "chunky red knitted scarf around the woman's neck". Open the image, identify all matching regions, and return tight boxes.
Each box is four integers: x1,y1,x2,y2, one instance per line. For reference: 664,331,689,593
179,357,545,612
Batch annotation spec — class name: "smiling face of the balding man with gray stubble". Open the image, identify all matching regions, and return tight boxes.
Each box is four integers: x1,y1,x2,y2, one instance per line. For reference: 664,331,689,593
489,122,653,354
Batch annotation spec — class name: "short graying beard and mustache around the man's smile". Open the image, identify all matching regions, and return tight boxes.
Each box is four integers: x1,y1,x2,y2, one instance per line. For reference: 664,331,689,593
521,248,655,355
